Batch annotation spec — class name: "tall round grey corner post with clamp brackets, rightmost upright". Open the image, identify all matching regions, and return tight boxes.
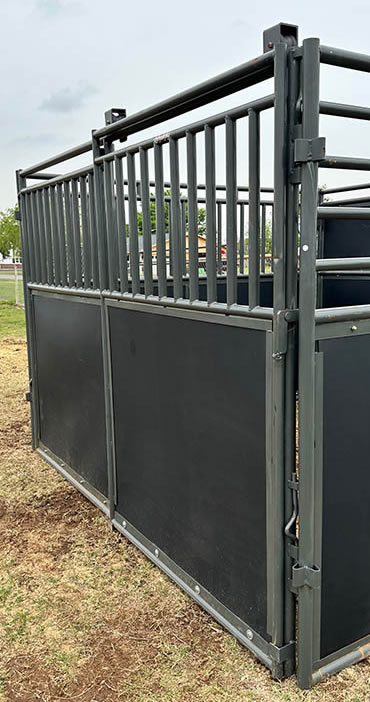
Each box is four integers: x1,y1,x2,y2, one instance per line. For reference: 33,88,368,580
298,39,320,689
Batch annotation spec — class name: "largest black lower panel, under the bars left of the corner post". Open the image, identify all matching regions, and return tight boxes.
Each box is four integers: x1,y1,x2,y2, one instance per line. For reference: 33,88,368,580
109,307,267,638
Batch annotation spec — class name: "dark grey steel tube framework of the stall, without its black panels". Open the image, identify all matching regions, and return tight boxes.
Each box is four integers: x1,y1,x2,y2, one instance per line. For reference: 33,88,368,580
17,20,370,688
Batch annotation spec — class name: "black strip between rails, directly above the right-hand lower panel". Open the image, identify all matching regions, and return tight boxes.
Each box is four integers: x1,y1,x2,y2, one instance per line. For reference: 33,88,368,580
323,275,370,307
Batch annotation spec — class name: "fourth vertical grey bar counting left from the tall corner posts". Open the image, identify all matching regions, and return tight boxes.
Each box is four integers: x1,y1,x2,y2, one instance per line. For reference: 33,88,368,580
186,132,199,302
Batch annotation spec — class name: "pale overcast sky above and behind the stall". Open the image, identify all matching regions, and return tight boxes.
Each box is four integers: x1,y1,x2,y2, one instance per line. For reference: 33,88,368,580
0,0,370,209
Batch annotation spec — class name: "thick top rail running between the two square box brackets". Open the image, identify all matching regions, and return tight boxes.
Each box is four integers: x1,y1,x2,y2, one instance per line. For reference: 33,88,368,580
95,50,275,140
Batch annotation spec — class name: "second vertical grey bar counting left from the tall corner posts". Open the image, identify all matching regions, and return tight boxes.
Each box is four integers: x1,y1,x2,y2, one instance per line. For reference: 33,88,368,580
225,117,237,305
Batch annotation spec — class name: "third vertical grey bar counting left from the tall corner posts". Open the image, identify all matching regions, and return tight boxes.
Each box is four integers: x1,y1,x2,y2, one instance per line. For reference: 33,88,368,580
204,124,217,304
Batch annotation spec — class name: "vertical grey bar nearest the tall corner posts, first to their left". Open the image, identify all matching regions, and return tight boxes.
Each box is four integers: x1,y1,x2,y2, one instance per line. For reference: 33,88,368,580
248,110,260,309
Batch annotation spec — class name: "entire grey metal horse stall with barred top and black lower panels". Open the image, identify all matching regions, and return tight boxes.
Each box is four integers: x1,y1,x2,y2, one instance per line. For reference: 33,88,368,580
17,25,370,687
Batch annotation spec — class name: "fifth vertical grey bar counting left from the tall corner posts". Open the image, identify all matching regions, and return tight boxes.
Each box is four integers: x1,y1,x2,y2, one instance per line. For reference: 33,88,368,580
170,137,183,300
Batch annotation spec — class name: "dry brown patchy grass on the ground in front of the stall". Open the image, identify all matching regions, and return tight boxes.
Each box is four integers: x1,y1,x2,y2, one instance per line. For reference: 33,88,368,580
0,339,370,702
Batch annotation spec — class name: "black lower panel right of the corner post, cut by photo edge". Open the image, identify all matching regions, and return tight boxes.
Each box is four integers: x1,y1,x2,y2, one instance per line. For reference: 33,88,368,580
320,336,370,657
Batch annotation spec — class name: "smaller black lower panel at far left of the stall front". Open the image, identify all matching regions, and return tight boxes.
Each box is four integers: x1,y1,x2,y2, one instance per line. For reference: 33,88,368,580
34,295,107,495
